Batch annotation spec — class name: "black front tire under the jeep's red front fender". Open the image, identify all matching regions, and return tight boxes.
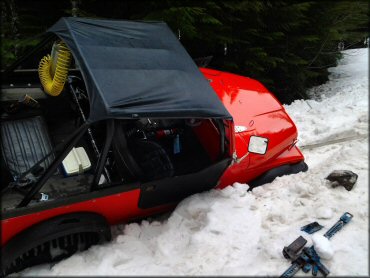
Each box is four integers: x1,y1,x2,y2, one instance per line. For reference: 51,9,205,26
248,161,308,191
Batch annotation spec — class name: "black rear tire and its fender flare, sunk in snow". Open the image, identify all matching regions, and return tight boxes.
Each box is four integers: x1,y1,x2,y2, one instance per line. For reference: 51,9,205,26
1,212,111,276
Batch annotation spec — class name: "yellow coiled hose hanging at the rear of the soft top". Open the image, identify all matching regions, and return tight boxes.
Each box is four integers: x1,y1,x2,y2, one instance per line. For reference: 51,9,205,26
38,42,72,96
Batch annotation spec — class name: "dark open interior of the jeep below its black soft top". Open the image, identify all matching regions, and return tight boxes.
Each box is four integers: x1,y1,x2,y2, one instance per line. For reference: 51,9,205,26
0,39,229,211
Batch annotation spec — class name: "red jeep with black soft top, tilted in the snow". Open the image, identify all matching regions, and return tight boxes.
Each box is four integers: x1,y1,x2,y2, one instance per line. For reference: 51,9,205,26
1,18,307,275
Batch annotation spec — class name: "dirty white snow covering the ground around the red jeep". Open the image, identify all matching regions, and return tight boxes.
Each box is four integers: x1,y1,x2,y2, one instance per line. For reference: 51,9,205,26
19,49,369,276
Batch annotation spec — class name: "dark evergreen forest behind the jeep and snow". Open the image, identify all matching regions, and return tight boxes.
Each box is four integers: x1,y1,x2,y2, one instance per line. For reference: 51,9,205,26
1,0,370,103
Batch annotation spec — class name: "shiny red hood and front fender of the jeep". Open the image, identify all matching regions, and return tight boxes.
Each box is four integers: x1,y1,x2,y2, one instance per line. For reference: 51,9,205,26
201,69,304,188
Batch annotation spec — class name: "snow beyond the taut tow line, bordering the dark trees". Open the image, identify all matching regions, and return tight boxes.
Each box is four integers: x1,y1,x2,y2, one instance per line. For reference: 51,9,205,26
285,48,369,146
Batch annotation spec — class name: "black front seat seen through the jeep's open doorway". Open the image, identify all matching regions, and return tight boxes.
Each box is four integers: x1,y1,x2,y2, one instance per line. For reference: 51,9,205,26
113,124,174,182
